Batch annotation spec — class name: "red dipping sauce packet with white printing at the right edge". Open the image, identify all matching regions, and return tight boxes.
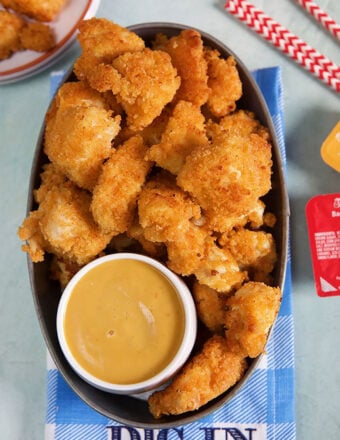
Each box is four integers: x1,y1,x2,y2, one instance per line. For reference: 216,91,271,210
306,194,340,296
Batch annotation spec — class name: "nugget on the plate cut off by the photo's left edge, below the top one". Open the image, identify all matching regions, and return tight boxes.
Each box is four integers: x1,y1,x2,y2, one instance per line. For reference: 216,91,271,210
0,11,26,60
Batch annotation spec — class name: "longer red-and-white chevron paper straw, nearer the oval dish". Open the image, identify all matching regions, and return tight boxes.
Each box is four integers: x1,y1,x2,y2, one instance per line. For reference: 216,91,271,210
225,0,340,92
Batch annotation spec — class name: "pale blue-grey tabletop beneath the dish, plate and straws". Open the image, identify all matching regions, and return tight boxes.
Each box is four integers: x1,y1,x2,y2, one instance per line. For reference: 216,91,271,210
0,0,340,440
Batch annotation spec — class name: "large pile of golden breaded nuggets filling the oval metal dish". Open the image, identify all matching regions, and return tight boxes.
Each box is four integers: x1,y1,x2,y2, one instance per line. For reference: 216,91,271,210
19,18,281,418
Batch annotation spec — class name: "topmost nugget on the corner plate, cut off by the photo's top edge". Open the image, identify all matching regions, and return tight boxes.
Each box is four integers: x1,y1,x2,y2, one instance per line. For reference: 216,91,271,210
0,0,65,21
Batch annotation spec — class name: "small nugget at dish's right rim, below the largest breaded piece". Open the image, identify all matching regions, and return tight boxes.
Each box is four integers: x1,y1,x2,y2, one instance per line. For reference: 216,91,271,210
219,228,277,283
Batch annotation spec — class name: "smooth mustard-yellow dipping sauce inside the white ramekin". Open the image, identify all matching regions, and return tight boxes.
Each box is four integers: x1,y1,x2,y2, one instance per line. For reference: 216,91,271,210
64,259,184,384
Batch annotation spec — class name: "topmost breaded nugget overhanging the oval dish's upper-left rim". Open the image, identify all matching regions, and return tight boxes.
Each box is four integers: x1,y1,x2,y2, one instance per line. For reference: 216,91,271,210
74,17,145,92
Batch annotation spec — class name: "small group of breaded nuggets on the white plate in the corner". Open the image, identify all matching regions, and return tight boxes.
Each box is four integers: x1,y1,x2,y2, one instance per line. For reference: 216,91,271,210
0,0,66,61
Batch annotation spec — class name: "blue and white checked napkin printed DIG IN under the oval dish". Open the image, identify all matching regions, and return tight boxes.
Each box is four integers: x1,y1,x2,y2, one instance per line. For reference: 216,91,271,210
45,67,296,440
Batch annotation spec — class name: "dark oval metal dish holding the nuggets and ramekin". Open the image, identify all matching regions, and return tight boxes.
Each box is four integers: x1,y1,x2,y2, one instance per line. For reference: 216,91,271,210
27,23,289,428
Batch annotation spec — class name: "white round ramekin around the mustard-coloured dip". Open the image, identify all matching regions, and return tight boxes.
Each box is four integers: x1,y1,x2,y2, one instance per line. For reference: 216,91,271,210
57,253,197,394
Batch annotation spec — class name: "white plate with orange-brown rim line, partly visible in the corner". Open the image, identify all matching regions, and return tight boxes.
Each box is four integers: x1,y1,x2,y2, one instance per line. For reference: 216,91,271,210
0,0,100,85
